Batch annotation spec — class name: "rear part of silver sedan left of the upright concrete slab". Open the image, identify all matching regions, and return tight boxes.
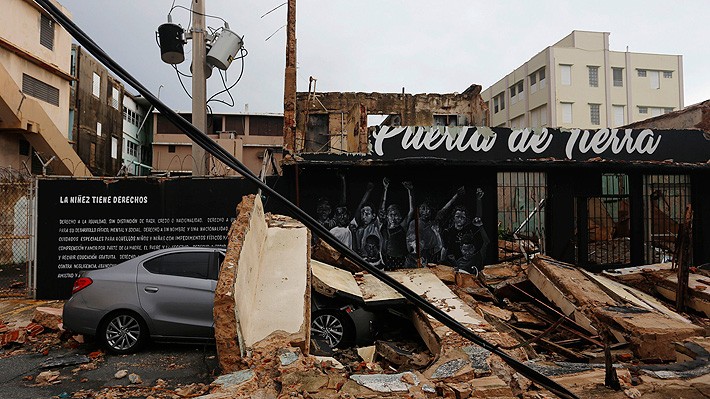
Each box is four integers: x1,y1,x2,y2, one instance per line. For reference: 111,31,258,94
63,247,224,354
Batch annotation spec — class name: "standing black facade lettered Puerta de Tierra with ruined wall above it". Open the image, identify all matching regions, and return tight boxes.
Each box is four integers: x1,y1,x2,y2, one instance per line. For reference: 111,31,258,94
284,85,710,271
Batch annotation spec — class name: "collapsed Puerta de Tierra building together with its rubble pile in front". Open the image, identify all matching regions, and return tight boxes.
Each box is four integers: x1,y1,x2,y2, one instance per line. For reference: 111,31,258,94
204,85,710,398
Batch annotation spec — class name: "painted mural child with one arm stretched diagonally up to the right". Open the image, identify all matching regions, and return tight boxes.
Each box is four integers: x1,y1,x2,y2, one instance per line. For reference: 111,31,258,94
407,186,465,267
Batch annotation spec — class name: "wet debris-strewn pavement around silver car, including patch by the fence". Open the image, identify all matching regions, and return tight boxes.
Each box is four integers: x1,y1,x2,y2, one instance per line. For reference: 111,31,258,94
0,299,218,399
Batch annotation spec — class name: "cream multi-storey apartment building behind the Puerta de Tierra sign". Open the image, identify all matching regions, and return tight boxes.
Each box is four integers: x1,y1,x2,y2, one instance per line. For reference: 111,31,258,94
481,31,683,129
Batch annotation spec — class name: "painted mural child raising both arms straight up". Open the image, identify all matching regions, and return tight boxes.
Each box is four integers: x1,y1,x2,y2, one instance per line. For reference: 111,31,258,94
380,177,414,270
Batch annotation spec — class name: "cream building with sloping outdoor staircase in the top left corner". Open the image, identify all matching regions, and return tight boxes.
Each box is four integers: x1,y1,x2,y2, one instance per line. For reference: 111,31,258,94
0,0,91,176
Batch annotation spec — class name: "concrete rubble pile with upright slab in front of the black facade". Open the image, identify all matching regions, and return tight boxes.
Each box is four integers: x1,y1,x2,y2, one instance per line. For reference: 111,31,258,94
206,196,710,399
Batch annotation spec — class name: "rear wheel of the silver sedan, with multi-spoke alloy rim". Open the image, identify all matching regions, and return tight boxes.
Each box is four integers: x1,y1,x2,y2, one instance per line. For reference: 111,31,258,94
98,312,148,354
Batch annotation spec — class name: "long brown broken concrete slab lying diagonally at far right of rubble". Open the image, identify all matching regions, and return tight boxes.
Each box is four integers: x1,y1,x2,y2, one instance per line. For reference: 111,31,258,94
528,257,704,361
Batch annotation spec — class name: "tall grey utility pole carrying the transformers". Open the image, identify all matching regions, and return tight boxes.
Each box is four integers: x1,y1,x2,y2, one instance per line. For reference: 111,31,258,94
192,0,210,176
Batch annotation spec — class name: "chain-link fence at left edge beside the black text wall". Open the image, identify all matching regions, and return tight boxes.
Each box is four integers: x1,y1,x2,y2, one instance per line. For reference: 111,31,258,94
0,168,33,297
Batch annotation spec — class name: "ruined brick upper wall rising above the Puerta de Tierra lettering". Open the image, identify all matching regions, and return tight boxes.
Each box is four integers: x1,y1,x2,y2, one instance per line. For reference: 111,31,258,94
295,85,487,153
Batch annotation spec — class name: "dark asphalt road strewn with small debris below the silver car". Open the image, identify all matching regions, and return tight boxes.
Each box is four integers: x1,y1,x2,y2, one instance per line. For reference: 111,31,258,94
0,343,218,399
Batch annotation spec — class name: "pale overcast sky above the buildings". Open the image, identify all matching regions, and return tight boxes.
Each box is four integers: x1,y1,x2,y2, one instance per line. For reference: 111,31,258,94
60,0,710,113
